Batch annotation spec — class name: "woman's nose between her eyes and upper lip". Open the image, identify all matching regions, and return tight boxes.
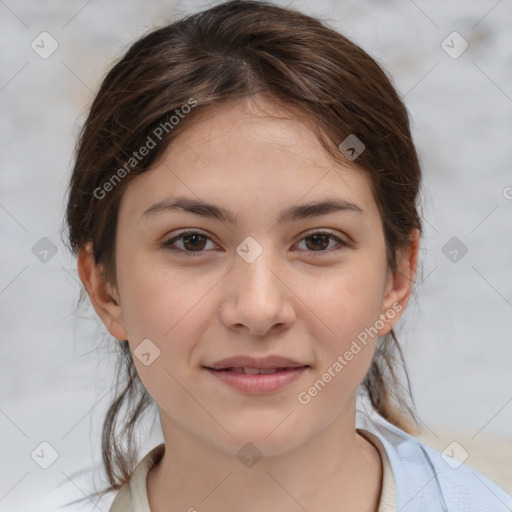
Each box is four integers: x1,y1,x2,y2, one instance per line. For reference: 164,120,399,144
220,249,295,336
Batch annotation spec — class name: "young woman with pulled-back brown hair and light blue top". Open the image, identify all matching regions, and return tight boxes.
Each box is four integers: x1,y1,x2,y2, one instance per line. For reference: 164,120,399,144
63,1,512,512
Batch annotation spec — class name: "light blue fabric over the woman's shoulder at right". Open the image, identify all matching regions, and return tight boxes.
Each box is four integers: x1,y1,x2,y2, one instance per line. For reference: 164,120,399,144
357,411,512,512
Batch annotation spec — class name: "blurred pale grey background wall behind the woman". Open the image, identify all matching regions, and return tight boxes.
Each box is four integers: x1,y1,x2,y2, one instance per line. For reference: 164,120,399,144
0,0,512,512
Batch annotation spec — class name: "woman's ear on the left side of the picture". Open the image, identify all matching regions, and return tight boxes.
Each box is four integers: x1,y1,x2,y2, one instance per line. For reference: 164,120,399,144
78,242,128,340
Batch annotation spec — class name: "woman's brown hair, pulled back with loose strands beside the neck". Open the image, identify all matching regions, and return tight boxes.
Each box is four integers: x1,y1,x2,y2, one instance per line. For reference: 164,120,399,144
65,0,421,504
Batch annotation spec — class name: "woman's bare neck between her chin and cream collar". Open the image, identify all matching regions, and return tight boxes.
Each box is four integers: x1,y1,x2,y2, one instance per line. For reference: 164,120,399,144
147,402,382,512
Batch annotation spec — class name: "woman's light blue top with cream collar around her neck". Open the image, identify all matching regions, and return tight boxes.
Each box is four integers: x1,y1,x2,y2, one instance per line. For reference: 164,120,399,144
110,411,512,512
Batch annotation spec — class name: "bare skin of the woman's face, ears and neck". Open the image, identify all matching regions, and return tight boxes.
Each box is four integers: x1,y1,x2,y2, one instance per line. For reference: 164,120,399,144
78,97,419,512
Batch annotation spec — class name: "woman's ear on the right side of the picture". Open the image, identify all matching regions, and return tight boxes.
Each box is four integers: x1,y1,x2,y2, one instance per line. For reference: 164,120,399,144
378,229,420,336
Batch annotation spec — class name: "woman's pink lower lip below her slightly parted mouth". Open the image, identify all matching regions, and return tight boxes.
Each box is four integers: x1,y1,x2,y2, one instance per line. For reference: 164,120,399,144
205,366,309,395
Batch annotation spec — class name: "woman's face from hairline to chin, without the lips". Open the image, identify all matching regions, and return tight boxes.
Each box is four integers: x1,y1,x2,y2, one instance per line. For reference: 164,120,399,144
82,98,409,454
